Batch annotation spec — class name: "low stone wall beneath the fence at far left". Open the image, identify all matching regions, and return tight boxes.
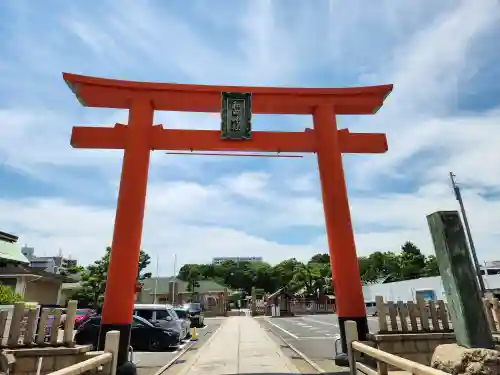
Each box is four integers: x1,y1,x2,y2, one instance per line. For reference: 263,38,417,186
4,345,91,375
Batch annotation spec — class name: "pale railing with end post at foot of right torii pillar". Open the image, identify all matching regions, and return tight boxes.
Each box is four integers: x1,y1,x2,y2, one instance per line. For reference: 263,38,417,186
345,320,447,375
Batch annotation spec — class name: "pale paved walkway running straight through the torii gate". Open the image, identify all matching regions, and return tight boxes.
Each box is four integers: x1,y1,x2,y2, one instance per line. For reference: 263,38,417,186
179,316,299,375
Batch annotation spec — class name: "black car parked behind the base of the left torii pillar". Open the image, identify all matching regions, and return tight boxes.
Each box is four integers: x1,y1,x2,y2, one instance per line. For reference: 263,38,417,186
75,315,180,351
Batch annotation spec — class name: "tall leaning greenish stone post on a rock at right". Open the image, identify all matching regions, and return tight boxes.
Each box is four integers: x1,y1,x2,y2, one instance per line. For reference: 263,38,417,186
427,211,493,348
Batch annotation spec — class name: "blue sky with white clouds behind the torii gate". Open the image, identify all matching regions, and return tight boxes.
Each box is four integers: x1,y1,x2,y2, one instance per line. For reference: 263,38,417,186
0,0,500,274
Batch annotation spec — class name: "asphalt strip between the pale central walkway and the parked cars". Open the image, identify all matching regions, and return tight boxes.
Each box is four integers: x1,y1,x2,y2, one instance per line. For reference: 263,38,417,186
134,318,223,374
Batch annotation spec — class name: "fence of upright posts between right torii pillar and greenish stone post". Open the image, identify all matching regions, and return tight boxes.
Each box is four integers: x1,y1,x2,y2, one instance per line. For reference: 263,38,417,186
375,296,453,333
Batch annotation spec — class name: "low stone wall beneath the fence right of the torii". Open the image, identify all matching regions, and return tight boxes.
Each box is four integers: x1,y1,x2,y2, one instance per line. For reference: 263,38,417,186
368,333,456,370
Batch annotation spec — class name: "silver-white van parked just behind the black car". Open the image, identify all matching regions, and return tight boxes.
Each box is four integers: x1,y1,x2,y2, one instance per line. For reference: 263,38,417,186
134,304,189,340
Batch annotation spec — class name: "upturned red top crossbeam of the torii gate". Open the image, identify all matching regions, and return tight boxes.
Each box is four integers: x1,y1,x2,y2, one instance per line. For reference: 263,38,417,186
63,73,392,115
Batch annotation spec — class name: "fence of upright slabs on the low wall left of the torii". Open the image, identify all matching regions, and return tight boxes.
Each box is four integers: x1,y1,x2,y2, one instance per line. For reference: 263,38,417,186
0,301,77,348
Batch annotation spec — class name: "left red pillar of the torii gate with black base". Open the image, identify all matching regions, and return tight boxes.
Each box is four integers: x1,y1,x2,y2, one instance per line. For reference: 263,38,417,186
100,98,154,364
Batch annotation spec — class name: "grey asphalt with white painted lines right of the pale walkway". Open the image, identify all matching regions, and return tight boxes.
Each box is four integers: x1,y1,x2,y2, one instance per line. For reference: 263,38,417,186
260,314,378,372
